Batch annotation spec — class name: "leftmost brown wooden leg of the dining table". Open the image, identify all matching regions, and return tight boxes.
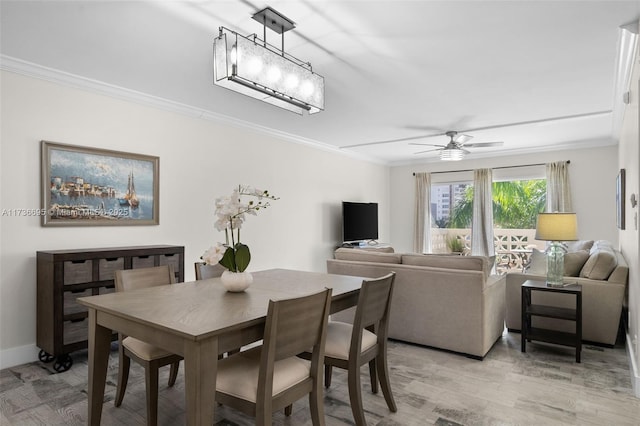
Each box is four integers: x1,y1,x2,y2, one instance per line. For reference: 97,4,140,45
87,309,111,426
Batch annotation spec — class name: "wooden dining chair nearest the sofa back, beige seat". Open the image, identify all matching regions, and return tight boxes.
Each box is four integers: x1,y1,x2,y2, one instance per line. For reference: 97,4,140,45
324,272,397,426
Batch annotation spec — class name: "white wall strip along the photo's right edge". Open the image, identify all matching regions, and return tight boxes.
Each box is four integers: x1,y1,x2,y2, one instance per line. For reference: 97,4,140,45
619,35,640,397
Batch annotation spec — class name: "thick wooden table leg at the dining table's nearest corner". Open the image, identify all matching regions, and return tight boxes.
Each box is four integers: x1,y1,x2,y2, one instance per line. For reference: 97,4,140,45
184,337,218,426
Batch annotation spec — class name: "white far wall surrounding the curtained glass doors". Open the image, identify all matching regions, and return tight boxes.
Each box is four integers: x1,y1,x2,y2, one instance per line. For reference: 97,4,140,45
390,146,618,251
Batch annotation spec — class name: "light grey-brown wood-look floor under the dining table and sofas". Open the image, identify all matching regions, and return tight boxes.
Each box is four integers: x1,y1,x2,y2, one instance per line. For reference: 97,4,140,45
0,331,640,426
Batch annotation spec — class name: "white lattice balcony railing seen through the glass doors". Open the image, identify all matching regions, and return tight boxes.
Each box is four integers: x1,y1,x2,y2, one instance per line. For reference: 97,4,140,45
431,228,545,273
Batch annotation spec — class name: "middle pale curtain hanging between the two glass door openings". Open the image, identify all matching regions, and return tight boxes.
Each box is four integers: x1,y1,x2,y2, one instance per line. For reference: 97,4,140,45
471,169,496,256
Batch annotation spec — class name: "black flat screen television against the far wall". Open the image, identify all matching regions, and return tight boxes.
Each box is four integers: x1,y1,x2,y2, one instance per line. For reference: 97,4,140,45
342,201,378,242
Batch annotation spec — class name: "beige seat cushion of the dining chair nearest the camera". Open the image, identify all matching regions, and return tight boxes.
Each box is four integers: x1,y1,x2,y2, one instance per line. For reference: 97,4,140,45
216,347,311,402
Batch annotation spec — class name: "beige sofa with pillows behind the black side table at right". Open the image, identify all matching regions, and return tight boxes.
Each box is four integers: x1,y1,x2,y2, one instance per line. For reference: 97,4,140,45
506,240,629,346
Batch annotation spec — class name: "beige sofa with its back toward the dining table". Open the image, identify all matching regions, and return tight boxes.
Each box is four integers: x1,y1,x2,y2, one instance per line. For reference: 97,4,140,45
327,248,505,359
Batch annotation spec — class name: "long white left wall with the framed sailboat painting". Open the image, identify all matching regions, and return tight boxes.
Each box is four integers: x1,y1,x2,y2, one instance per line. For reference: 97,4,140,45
0,72,390,368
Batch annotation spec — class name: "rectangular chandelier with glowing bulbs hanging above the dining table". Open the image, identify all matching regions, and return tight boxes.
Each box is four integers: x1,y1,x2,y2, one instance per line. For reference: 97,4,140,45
213,7,324,114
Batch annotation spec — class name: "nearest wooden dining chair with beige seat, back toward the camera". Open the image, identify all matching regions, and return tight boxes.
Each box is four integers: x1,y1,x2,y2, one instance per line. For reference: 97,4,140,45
216,289,331,426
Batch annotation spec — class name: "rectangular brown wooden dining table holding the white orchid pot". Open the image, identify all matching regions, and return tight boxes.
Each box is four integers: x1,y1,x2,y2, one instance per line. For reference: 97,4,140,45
78,269,364,426
